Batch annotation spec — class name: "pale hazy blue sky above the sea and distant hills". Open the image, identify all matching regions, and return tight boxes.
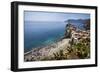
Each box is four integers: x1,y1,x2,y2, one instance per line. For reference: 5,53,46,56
24,11,90,22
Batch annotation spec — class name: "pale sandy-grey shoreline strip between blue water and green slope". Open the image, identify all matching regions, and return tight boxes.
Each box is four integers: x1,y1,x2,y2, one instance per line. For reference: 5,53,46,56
24,38,71,61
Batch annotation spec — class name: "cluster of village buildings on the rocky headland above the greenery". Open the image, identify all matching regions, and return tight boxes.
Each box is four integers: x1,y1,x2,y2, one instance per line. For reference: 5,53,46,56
65,23,90,43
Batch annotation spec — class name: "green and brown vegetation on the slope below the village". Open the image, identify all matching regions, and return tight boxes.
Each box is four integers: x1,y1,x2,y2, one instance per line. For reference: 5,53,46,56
54,38,90,60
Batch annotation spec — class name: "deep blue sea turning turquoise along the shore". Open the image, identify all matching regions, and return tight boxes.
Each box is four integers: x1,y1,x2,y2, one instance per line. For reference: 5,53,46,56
24,21,83,52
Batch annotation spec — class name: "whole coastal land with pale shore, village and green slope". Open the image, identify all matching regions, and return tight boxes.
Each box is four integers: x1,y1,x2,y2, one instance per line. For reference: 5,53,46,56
24,21,90,62
